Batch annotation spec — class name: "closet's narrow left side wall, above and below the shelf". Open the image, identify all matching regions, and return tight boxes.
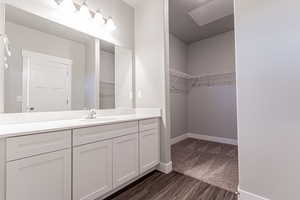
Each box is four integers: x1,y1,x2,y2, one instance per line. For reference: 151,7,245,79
170,34,188,138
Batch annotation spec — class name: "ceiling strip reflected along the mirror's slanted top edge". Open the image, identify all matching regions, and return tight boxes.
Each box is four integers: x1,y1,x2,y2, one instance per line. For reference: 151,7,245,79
5,5,91,43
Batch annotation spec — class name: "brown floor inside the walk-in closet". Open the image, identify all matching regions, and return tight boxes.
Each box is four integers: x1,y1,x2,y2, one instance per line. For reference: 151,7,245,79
172,138,239,192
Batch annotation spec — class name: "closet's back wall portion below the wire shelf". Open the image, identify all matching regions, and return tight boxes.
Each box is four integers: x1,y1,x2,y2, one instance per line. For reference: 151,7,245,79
188,85,237,139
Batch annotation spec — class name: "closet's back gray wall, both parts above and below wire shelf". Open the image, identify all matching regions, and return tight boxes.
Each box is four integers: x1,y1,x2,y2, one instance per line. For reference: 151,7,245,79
188,31,237,139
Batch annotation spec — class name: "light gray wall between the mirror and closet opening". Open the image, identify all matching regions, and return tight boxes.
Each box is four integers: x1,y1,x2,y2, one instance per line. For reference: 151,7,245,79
135,0,171,164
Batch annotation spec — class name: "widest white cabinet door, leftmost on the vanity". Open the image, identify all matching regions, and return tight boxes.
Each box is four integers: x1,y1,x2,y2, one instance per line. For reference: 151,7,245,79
6,150,71,200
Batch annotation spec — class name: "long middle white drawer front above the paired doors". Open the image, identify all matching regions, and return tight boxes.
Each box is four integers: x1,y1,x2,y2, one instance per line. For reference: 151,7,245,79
73,121,138,146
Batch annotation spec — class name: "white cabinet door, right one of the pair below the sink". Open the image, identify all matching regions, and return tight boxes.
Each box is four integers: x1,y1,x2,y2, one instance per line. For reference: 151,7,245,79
113,134,139,188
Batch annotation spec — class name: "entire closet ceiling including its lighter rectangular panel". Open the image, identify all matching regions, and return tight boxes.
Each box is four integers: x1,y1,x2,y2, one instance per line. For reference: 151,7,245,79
169,0,234,44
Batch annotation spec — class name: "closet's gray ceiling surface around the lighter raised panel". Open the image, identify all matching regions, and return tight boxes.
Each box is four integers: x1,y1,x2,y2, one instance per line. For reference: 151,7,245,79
169,0,234,43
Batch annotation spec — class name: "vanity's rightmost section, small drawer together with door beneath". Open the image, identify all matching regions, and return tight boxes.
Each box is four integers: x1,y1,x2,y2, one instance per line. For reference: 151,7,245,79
139,119,160,173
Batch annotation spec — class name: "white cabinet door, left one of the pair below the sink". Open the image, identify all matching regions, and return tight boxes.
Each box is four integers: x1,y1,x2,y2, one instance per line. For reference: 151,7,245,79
73,140,112,200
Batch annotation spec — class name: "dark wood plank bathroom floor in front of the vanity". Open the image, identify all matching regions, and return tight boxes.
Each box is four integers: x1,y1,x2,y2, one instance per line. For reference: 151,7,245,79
106,171,237,200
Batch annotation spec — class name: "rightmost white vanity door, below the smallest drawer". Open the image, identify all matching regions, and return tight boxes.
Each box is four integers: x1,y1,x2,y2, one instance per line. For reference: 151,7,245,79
140,129,159,173
